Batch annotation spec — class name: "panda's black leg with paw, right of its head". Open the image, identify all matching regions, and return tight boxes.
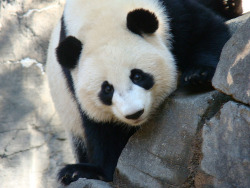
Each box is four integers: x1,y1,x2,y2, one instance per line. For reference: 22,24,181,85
177,1,230,89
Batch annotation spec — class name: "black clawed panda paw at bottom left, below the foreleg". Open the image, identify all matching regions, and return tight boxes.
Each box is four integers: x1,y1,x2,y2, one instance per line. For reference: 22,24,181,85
57,164,104,185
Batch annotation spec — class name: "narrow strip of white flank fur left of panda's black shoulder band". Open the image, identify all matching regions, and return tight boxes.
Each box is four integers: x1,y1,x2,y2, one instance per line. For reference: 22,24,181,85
46,24,84,136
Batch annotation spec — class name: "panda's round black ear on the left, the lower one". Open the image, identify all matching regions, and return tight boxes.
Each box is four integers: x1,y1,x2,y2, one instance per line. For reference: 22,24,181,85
56,36,82,69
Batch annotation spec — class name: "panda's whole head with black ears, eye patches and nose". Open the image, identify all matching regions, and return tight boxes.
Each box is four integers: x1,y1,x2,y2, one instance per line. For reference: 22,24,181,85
56,8,176,126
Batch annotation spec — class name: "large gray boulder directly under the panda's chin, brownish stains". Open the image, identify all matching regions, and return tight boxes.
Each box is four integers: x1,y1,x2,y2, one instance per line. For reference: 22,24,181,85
115,91,229,188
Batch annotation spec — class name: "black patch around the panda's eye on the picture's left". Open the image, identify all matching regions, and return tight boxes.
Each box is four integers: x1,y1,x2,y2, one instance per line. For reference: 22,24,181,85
98,81,114,106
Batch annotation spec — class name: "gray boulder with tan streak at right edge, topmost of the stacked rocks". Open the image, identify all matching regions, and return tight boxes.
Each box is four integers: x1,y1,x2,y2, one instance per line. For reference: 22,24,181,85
212,18,250,104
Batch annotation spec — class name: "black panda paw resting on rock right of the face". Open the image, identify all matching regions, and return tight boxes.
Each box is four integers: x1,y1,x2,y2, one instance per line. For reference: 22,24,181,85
181,67,215,86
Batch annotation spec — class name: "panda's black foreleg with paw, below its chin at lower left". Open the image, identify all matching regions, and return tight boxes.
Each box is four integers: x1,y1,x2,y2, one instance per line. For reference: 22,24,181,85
58,119,138,185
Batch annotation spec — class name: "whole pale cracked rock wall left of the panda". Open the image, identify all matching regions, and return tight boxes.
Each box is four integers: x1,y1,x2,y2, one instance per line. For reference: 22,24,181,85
0,0,74,188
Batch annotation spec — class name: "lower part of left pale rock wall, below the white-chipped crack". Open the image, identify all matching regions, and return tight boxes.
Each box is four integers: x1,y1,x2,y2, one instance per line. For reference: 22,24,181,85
0,59,74,188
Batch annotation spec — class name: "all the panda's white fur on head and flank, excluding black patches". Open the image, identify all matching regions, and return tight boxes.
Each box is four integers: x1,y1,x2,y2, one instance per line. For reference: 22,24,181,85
47,0,177,133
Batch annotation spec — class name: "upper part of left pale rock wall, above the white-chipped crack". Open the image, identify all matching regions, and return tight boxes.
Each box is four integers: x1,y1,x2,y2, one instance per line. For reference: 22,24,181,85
0,0,64,63
